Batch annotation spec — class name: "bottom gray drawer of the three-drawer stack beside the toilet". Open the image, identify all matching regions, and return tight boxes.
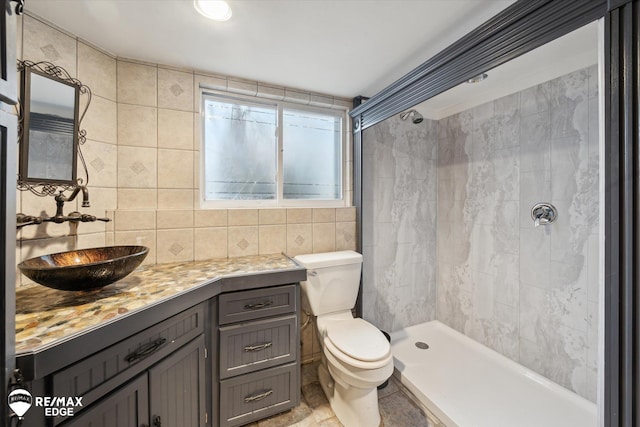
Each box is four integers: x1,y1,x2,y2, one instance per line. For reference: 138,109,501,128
220,363,300,427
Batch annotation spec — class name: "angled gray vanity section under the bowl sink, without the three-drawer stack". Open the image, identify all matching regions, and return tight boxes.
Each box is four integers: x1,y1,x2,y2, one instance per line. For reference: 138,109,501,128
25,303,210,427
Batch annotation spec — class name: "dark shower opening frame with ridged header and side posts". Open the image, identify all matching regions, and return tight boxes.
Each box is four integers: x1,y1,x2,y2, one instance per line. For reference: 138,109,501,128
350,0,640,427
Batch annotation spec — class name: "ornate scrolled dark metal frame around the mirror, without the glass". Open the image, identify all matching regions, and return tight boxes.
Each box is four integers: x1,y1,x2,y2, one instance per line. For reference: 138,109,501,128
17,60,91,196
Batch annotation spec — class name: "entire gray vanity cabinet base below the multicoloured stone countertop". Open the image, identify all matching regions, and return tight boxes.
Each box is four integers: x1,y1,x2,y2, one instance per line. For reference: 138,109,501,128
13,268,306,427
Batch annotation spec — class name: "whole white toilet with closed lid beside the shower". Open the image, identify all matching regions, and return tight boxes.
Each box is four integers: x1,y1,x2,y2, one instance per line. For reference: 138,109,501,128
294,251,393,427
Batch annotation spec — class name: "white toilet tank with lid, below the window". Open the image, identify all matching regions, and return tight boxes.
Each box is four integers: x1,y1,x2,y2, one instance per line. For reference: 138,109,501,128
294,251,362,316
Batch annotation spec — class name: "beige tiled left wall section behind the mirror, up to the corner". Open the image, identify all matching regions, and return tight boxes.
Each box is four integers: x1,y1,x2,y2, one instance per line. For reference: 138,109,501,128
16,15,118,278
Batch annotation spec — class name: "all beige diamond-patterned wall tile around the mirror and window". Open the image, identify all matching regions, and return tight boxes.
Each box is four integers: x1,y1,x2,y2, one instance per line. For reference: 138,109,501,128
16,15,356,361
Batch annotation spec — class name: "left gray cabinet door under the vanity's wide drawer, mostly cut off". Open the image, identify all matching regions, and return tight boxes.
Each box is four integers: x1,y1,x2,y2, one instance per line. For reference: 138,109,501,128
64,374,149,427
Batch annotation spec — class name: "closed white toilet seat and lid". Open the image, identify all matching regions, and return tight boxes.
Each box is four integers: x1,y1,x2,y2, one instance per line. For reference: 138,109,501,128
323,318,392,369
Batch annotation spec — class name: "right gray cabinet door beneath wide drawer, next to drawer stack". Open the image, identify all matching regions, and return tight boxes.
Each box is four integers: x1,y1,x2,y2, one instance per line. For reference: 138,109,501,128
149,335,206,427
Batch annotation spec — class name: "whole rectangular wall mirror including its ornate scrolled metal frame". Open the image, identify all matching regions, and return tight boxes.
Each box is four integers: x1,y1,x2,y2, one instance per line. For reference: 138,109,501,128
18,61,91,194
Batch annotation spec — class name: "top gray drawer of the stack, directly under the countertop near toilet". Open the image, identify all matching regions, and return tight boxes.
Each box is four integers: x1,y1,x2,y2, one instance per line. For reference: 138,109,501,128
218,285,297,325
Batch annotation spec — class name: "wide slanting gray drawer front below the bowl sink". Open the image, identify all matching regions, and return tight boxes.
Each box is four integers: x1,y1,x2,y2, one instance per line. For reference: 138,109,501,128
51,304,205,423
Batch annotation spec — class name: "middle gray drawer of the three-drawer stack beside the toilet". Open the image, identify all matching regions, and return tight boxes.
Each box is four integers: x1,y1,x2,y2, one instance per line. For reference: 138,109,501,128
220,314,298,378
